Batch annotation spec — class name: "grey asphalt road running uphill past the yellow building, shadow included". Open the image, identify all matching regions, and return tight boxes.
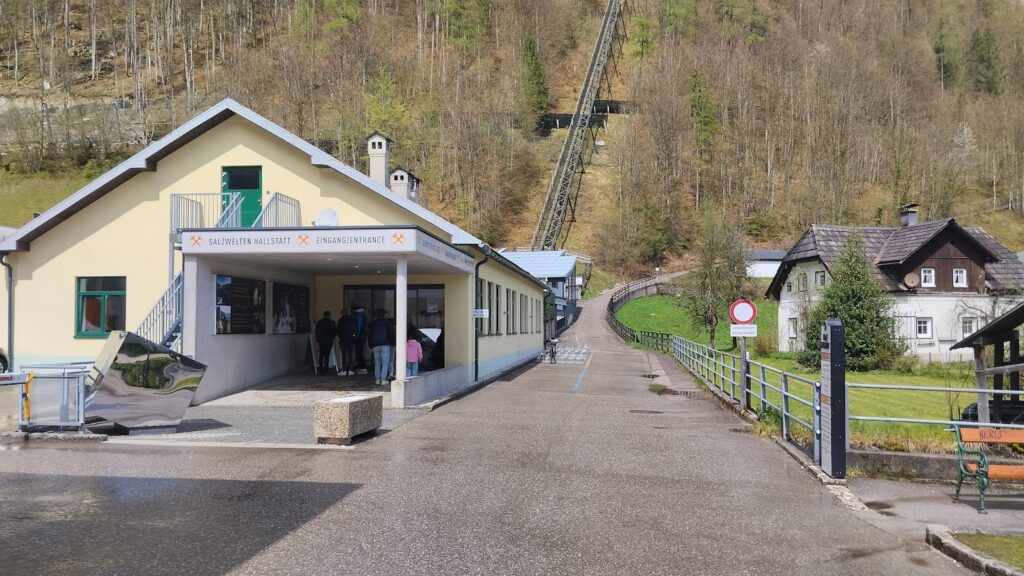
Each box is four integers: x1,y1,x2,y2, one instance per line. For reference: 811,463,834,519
0,284,970,576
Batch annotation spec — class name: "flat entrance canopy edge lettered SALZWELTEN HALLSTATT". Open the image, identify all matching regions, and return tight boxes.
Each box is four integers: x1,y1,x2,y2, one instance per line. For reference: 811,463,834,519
181,227,476,274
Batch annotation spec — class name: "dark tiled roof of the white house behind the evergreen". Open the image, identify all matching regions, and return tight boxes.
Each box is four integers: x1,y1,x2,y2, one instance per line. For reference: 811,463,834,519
766,218,1024,298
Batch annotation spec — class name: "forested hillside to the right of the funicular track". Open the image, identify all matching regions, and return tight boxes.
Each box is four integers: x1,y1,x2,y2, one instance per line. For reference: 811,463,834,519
601,0,1024,266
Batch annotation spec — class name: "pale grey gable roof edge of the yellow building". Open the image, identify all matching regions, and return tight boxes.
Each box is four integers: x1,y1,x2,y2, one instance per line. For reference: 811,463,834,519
0,98,483,252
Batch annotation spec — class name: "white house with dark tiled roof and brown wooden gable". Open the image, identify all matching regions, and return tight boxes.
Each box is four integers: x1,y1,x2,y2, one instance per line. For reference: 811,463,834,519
767,207,1024,361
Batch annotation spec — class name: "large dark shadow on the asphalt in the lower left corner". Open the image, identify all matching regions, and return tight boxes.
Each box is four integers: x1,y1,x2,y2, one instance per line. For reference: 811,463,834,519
0,474,359,575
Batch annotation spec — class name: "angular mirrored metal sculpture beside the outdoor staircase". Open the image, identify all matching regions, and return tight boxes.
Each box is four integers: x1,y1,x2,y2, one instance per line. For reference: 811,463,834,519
85,332,206,429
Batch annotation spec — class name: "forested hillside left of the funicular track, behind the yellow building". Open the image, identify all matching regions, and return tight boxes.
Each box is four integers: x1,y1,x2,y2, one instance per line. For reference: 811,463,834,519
0,0,603,242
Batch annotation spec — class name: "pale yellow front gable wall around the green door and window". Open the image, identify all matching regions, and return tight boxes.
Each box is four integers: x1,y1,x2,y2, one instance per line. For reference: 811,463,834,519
0,117,447,358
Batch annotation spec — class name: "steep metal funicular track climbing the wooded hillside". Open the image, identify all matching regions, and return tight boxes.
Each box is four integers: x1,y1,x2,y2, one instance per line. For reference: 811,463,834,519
530,0,626,250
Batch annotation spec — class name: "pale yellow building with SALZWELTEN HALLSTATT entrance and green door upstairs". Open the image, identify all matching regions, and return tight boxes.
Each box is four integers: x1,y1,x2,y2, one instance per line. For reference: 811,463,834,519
0,99,546,407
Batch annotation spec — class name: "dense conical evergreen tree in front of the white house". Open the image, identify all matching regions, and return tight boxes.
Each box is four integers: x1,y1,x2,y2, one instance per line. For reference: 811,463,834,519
800,234,903,371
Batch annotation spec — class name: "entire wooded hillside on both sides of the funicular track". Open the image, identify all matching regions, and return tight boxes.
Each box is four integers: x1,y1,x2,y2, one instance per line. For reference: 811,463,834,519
0,0,1024,272
